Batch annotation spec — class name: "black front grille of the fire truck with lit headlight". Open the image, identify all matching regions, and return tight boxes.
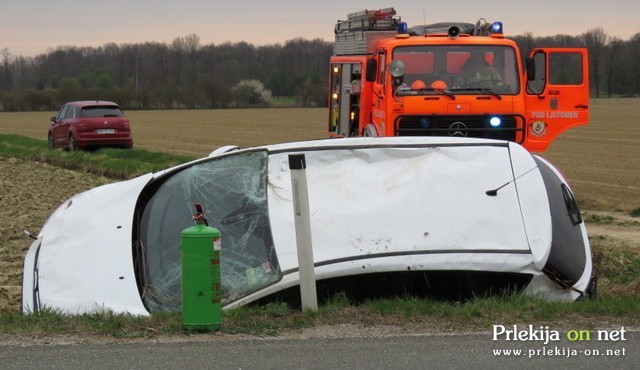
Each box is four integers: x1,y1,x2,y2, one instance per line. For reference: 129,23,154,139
396,115,524,142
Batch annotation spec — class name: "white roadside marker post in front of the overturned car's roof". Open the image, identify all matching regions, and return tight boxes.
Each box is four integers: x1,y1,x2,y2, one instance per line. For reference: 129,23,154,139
289,154,318,311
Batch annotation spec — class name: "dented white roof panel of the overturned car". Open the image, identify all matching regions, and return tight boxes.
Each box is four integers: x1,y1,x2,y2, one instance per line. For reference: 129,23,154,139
269,143,529,271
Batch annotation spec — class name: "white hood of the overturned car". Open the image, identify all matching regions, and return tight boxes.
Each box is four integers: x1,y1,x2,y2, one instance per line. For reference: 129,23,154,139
23,174,153,315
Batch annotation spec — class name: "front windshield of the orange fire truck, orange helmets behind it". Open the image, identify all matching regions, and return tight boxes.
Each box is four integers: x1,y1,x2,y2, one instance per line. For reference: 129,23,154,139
393,45,520,96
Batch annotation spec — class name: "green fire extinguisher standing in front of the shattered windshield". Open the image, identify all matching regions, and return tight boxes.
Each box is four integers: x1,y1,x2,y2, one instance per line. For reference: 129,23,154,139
180,204,221,331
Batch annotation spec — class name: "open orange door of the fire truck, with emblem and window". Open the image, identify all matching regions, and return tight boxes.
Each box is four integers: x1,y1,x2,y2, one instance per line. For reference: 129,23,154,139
523,48,589,151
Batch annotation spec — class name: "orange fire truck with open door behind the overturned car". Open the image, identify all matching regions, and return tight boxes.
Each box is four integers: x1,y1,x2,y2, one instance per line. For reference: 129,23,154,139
329,8,589,151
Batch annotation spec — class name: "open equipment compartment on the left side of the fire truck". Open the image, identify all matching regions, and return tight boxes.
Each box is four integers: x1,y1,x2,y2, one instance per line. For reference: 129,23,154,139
329,63,362,136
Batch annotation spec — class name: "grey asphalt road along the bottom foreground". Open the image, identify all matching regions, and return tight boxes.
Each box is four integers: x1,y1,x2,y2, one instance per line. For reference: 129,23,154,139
0,332,640,369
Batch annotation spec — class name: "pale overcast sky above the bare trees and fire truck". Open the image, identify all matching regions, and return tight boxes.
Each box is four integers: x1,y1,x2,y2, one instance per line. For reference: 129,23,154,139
0,0,640,56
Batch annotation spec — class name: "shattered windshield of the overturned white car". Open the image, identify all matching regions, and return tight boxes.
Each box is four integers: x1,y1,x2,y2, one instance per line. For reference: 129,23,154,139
136,151,281,312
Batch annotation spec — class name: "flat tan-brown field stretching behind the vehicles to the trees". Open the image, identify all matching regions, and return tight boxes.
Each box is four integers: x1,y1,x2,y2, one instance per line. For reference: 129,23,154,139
0,99,640,212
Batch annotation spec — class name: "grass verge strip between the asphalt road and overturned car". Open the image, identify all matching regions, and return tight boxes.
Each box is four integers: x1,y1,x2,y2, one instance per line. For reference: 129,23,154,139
0,294,640,339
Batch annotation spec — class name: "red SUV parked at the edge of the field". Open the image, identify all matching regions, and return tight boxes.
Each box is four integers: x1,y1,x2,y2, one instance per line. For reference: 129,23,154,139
49,100,133,151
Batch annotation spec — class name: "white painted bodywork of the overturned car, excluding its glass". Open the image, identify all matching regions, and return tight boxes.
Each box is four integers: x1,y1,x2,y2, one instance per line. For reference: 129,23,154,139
22,137,592,315
